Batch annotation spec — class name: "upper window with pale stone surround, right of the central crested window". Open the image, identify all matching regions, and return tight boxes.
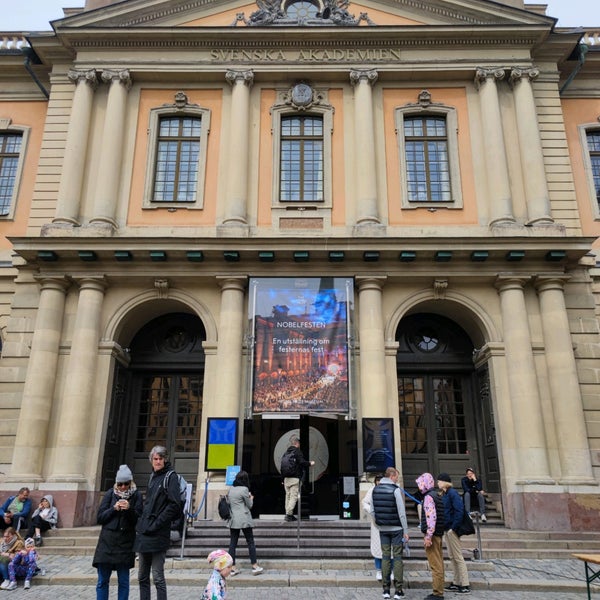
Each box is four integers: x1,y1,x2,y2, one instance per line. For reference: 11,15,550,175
395,102,463,208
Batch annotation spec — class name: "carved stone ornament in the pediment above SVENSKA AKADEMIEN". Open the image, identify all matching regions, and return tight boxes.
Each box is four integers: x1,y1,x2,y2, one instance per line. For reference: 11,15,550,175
232,0,375,27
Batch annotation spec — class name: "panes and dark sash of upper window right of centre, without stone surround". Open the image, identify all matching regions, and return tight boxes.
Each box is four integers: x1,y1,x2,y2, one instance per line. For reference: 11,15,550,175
404,116,452,202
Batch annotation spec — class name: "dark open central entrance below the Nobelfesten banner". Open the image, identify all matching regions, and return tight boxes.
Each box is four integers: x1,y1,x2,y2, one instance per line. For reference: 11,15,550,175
242,414,358,519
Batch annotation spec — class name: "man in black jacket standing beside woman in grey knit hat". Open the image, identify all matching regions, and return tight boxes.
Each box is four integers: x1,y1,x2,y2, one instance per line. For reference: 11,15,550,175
134,446,183,600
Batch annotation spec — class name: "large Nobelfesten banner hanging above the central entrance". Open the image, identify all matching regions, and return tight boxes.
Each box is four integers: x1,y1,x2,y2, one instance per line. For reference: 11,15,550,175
250,277,353,413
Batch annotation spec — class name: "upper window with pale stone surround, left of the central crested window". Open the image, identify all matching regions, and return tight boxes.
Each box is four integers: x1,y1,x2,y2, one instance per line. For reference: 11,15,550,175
144,104,210,209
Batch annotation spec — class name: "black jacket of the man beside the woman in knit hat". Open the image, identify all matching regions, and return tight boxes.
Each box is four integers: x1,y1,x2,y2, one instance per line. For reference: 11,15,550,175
134,463,183,552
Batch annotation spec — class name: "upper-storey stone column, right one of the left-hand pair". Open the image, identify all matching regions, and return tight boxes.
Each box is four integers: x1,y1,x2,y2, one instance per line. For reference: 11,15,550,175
90,70,132,232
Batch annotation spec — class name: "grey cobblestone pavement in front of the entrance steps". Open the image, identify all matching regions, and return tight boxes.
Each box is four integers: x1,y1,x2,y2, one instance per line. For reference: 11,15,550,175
7,556,600,600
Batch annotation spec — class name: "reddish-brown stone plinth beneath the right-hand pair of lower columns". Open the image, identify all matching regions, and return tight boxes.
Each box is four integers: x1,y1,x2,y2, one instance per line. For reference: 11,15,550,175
503,491,600,531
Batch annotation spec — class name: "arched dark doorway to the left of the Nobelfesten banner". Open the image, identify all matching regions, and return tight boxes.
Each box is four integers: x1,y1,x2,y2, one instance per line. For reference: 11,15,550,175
102,313,206,489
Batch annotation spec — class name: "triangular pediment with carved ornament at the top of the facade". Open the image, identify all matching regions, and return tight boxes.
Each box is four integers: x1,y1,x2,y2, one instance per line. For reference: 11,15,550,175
53,0,552,31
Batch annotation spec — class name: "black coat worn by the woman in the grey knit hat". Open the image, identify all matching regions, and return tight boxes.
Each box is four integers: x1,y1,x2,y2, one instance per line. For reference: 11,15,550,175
92,489,142,569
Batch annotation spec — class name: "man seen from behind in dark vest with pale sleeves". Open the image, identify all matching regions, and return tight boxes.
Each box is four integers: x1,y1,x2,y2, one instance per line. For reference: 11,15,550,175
371,467,408,600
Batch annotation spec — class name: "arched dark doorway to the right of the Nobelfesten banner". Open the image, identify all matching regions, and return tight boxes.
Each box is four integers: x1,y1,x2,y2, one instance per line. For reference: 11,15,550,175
396,313,499,493
